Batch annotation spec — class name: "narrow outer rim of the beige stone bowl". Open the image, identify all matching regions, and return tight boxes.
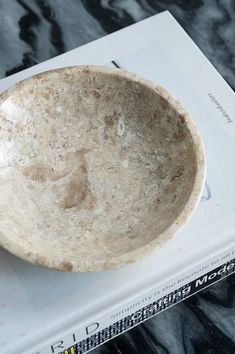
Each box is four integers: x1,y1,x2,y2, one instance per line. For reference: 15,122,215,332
0,65,206,272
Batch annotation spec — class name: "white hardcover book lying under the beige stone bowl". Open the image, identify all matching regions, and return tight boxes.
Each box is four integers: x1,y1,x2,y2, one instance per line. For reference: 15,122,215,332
0,12,235,354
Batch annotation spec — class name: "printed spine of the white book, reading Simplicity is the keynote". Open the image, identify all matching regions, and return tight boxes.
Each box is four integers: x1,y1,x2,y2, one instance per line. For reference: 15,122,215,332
35,249,235,354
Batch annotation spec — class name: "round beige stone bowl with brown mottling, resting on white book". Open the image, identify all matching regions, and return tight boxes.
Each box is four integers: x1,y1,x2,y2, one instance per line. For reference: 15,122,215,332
0,66,205,271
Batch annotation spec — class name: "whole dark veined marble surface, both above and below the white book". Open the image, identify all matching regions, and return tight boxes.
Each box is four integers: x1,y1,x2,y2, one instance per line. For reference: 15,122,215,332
0,0,235,354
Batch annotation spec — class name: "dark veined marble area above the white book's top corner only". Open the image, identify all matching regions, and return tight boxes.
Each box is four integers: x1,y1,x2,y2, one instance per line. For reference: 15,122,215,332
0,0,235,88
